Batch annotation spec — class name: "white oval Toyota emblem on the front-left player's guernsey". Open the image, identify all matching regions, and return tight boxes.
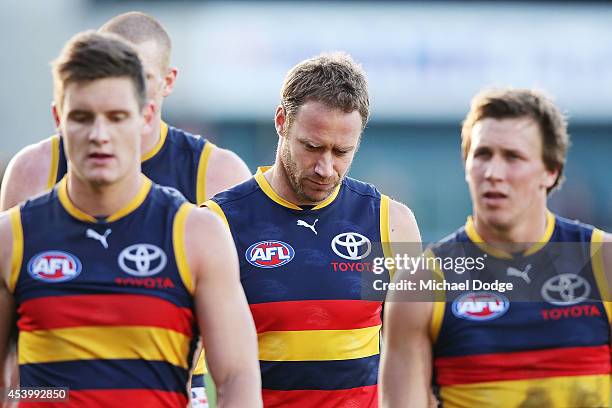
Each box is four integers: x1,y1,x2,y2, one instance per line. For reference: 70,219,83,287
119,244,166,277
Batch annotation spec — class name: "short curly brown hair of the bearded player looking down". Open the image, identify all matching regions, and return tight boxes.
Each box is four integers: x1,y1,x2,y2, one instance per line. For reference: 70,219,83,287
281,52,370,129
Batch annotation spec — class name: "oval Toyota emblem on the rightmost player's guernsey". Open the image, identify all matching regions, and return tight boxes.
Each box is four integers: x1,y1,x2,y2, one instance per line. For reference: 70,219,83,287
542,273,591,306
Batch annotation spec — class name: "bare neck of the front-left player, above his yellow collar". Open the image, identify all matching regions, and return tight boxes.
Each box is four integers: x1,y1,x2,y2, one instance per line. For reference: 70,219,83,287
66,169,145,217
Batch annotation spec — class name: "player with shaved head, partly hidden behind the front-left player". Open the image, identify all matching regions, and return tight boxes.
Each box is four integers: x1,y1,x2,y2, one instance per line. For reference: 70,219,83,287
0,12,251,210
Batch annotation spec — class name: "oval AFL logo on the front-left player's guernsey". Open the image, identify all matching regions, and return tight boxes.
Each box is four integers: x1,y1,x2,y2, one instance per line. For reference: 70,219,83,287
28,251,81,282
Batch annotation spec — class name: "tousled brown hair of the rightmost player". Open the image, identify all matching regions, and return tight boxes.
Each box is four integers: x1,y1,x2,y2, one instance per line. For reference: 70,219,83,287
461,88,570,193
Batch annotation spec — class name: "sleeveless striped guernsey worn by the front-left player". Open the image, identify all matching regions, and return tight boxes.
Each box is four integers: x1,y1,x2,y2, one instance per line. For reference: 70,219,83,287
10,178,198,407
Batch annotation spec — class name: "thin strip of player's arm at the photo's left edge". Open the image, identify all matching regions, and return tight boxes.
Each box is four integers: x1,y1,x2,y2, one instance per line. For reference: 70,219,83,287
0,212,15,390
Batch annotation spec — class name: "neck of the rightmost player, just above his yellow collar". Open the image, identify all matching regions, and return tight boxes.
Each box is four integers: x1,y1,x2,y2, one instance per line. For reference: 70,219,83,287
474,206,548,252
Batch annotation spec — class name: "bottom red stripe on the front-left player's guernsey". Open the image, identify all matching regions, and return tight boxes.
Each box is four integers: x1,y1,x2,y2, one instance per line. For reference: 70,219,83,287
19,389,188,408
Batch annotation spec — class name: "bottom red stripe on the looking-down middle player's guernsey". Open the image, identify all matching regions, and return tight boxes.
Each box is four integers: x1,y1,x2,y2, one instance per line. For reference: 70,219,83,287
262,385,378,408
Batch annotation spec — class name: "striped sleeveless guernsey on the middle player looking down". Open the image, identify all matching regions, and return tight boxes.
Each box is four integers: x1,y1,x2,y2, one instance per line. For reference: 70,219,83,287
206,169,389,408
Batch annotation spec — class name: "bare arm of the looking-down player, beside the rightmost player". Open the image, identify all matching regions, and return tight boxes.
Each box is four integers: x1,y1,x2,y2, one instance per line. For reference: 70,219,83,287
379,202,434,407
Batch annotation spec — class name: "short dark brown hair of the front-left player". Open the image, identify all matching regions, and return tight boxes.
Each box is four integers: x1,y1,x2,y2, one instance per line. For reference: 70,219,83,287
52,31,147,110
